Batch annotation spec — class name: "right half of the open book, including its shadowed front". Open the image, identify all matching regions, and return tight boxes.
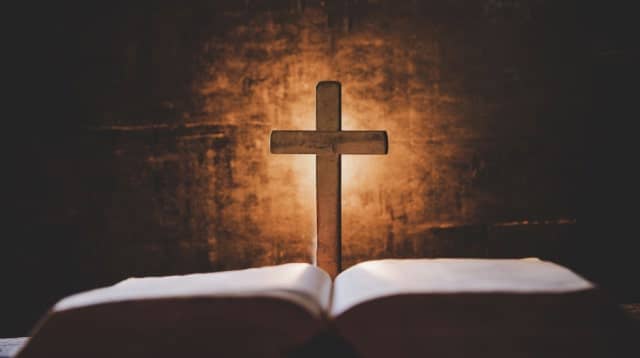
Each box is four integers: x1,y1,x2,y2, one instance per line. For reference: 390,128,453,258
330,259,632,357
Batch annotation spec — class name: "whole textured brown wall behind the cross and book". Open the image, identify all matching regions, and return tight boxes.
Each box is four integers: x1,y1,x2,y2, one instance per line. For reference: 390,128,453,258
6,0,631,332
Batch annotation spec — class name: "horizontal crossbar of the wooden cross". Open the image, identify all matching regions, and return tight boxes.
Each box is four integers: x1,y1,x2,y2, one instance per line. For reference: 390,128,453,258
270,131,388,155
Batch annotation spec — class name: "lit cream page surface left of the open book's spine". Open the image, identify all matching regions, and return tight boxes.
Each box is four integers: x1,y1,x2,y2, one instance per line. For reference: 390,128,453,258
53,263,331,317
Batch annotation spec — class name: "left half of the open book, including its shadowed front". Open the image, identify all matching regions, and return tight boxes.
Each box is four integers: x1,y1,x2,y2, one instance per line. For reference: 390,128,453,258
18,263,331,357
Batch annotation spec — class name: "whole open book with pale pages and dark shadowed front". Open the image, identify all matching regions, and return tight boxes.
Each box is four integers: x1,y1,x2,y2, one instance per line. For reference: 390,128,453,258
13,259,632,357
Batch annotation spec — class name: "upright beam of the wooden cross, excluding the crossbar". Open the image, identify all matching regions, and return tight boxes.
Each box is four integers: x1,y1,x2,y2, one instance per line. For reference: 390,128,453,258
316,81,342,277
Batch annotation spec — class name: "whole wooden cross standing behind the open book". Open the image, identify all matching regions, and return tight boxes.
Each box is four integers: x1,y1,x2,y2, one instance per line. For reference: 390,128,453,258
271,81,388,278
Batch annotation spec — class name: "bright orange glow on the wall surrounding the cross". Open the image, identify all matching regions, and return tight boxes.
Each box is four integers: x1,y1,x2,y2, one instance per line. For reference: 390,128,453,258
192,8,498,268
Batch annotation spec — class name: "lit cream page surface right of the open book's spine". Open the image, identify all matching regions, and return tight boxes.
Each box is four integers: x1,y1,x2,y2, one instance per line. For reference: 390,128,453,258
330,259,593,317
